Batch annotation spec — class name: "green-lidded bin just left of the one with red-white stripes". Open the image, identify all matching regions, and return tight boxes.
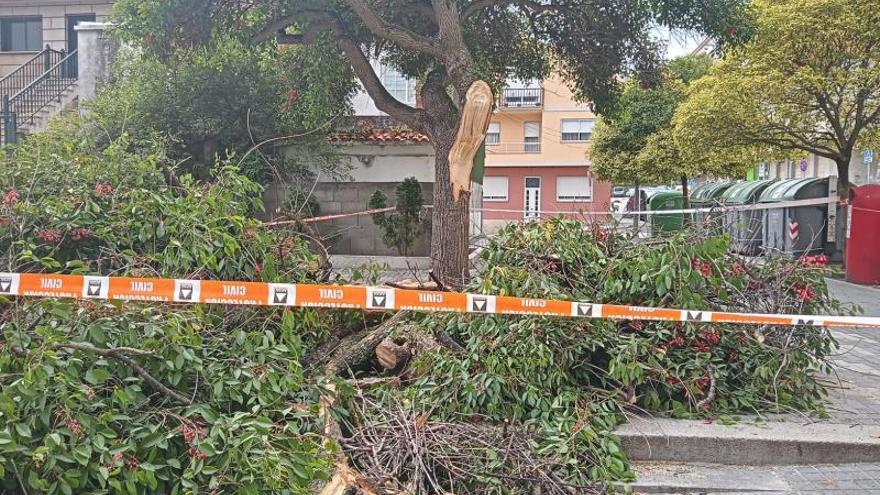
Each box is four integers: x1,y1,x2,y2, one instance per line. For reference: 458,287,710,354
724,180,776,256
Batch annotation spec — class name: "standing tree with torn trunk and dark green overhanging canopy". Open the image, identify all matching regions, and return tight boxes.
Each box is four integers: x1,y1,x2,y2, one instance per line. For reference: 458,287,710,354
111,0,748,287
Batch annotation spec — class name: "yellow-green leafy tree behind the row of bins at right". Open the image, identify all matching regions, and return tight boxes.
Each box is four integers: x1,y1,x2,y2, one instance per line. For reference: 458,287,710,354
675,0,880,194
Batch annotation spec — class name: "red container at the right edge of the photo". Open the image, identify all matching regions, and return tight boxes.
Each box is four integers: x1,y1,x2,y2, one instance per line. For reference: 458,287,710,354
846,184,880,285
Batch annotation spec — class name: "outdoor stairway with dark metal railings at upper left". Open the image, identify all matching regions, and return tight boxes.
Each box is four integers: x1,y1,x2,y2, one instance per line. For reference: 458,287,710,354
0,46,79,145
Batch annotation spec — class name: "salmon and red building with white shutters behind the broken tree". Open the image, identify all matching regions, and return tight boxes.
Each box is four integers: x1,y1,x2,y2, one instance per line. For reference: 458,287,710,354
482,77,611,233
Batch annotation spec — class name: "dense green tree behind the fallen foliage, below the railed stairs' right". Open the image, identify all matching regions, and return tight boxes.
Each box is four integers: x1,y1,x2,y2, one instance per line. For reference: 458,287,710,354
89,32,354,183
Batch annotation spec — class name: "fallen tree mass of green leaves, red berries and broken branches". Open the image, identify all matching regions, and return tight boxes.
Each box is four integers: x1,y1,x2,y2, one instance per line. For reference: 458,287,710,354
0,121,841,495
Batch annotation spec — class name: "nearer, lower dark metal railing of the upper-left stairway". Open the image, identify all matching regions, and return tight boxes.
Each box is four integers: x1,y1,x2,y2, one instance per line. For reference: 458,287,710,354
9,50,79,125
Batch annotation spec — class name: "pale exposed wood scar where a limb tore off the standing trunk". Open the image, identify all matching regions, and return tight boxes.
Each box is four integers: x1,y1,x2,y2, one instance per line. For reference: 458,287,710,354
449,81,493,201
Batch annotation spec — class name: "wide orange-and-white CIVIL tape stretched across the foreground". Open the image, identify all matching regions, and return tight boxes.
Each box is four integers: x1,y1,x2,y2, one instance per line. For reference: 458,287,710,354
0,273,880,328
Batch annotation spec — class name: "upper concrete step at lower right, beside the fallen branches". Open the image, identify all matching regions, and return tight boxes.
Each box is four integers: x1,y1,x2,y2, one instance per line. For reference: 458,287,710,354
615,417,880,466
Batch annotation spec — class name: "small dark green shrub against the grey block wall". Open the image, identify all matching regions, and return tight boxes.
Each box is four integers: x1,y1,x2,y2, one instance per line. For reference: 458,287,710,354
369,177,430,256
